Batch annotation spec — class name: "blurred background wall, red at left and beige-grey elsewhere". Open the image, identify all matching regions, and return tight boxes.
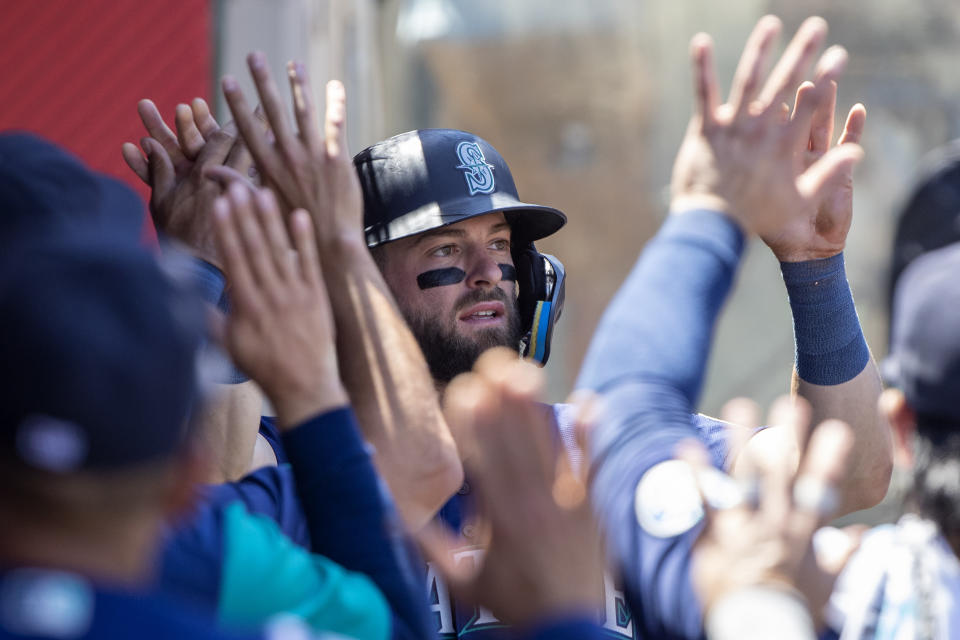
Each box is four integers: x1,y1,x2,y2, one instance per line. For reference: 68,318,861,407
0,0,960,413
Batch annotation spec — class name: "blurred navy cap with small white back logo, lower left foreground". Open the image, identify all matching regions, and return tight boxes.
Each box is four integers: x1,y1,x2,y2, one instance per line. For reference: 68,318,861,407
0,234,204,473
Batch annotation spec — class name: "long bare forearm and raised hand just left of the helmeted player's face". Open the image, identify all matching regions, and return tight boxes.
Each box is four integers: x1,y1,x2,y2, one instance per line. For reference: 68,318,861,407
223,53,463,529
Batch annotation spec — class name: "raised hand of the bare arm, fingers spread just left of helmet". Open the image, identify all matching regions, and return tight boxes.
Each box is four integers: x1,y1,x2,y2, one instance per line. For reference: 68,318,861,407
223,52,363,247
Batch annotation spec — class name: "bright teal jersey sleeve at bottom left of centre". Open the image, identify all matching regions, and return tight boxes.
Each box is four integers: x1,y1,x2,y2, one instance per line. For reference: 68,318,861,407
218,502,391,640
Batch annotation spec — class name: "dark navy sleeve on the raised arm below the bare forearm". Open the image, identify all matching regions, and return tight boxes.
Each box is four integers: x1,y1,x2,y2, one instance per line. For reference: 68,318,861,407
283,408,433,638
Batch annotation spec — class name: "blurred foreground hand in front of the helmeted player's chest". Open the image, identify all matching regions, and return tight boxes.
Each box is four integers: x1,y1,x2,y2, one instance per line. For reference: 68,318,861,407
419,349,603,624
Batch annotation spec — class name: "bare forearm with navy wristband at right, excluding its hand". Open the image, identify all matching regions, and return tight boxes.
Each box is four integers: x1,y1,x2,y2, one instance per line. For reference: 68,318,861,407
781,254,892,513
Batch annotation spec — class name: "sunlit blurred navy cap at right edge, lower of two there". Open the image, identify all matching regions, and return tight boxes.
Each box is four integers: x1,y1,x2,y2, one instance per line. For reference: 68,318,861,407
883,243,960,429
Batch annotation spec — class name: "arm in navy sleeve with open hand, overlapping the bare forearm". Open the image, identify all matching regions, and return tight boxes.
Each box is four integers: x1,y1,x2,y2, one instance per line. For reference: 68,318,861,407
215,185,430,638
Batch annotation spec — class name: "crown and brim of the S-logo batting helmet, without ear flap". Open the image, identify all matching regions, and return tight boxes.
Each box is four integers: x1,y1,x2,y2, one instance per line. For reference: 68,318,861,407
353,129,567,247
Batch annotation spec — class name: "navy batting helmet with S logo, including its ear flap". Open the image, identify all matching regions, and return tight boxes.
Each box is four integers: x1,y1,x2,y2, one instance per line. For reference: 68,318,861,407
353,129,567,364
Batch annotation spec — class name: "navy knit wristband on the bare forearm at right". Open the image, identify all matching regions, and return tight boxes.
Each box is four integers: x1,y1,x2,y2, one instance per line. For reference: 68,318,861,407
780,253,870,385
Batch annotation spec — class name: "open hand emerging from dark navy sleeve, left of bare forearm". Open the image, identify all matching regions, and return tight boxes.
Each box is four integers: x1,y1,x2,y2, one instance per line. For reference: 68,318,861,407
214,184,347,429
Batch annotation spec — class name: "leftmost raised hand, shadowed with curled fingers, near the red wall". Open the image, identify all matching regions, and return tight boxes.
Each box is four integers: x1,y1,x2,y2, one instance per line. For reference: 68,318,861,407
122,98,251,267
